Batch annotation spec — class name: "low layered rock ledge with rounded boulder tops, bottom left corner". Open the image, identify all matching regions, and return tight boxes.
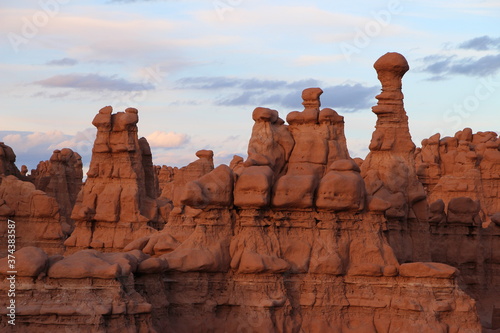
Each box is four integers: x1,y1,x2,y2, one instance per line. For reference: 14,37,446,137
0,247,153,332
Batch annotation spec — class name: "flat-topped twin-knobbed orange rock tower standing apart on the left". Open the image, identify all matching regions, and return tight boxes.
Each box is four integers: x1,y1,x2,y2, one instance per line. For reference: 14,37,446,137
64,107,164,253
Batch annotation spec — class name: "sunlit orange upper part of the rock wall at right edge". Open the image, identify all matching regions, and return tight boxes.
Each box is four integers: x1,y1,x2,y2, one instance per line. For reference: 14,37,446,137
415,128,500,222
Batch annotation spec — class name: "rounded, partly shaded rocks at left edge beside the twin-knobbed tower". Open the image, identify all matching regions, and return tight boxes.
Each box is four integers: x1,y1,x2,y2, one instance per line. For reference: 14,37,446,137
0,143,82,255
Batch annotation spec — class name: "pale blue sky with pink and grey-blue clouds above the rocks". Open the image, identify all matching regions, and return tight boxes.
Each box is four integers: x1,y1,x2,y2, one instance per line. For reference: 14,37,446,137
0,0,500,169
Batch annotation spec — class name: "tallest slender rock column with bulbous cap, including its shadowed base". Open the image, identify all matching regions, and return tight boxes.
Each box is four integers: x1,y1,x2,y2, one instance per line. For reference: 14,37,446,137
361,53,430,262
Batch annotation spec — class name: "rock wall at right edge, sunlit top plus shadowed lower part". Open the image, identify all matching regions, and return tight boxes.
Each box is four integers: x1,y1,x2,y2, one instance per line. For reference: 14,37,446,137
415,128,500,328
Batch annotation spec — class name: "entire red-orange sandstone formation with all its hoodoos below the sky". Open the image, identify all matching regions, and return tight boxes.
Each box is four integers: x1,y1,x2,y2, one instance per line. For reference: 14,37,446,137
0,53,500,333
